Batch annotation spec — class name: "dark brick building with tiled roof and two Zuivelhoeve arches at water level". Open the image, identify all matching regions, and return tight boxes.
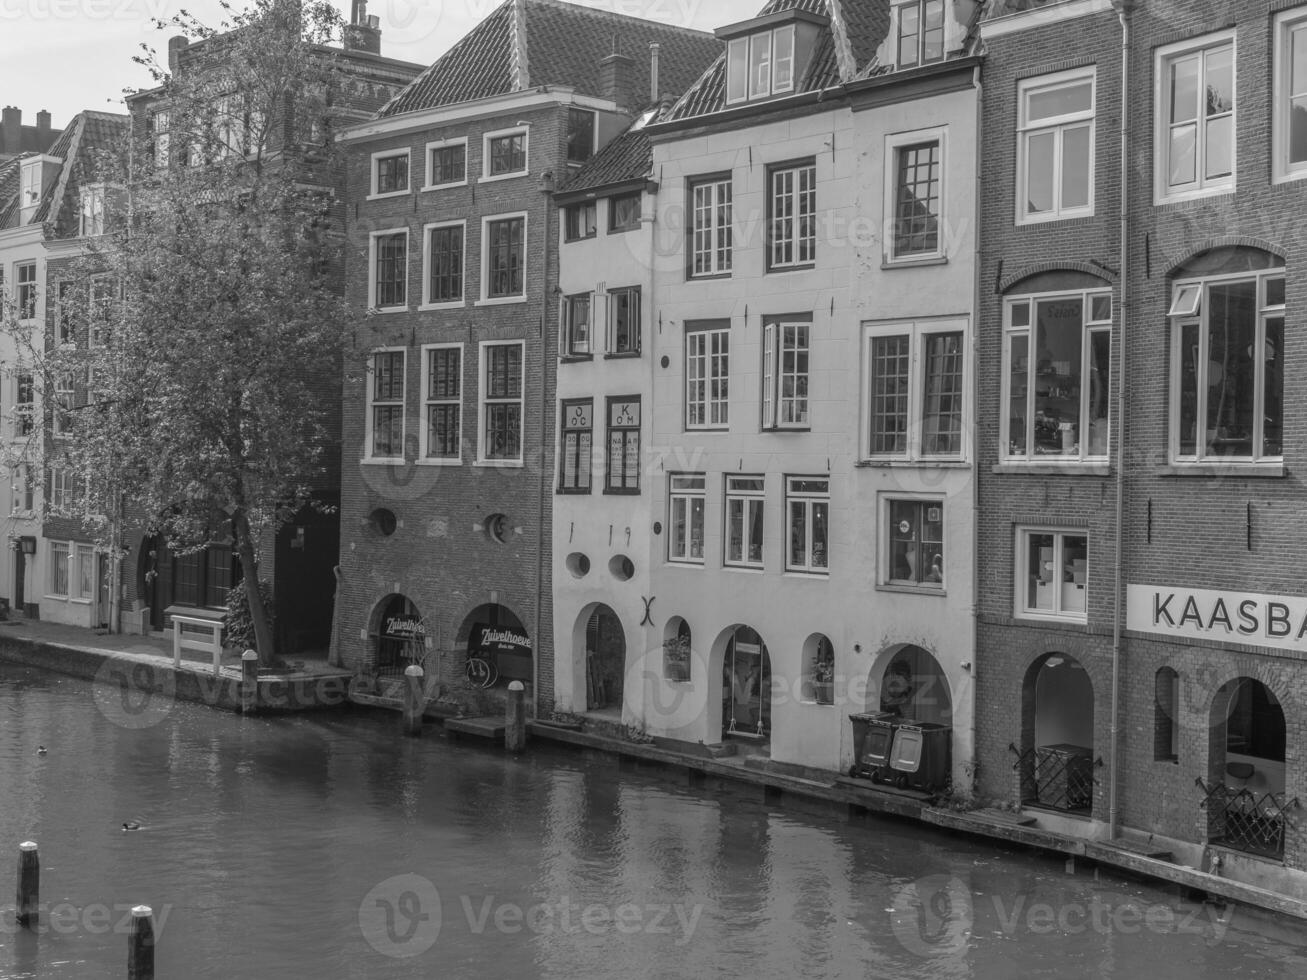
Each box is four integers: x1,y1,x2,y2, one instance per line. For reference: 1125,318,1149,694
326,0,719,711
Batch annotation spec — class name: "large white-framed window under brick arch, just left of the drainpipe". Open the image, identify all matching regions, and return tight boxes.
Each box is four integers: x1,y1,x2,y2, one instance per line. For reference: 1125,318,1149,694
999,289,1112,461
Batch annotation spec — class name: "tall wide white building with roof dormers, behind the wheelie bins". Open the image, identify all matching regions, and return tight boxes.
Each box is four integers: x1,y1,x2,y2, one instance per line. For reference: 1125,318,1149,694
644,0,978,789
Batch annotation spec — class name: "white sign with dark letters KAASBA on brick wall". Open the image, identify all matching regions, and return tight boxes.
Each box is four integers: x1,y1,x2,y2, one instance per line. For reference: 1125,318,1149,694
1125,585,1307,652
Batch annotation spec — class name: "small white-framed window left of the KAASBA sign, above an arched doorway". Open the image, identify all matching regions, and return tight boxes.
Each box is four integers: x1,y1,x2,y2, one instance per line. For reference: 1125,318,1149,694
1016,528,1089,622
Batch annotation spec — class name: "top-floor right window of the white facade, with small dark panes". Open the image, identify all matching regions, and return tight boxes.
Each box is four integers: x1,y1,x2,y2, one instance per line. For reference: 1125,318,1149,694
885,129,945,263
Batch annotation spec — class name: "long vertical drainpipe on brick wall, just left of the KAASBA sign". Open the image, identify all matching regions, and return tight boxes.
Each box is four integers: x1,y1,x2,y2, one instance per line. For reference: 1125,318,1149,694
1107,0,1134,839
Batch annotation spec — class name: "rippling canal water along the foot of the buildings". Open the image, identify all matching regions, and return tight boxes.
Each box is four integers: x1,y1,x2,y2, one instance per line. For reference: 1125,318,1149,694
0,665,1307,980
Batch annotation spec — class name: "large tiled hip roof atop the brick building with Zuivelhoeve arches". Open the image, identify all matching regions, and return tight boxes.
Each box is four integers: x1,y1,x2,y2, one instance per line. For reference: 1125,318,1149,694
379,0,726,116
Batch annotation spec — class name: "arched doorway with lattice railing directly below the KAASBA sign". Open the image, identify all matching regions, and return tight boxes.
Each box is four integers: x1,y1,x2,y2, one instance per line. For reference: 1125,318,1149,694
1204,677,1286,857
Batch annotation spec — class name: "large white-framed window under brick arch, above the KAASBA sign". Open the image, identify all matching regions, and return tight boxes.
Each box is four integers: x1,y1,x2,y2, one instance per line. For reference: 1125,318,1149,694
1170,268,1285,463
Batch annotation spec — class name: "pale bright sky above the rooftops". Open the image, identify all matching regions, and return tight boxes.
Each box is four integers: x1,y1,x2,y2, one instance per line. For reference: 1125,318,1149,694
0,0,765,128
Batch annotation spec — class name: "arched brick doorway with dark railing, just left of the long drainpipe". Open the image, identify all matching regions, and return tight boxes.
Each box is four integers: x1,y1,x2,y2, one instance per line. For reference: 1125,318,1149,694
1018,653,1095,815
